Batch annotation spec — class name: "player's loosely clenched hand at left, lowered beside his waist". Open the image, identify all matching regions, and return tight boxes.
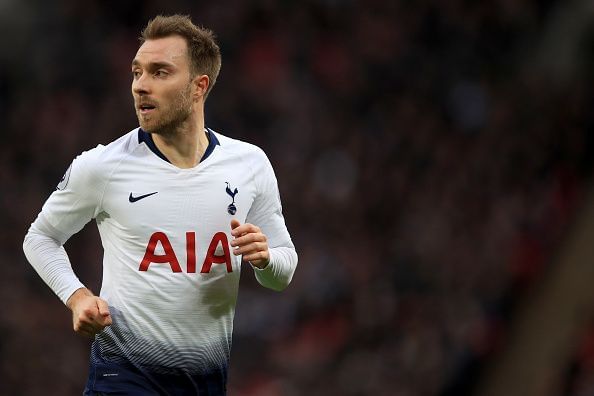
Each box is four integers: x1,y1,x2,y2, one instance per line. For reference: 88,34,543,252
66,289,111,338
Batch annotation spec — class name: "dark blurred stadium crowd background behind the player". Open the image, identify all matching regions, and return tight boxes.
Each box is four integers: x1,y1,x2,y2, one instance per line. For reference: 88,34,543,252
0,0,594,396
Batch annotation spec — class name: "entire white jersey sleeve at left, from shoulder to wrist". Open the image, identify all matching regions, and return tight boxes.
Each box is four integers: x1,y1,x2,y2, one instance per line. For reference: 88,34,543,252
23,146,104,303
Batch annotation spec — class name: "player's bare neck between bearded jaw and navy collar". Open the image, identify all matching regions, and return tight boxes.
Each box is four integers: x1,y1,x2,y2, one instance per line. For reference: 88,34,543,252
152,111,208,169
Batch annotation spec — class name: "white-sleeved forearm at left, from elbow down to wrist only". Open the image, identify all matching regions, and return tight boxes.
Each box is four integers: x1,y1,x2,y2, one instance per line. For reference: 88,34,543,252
23,218,84,304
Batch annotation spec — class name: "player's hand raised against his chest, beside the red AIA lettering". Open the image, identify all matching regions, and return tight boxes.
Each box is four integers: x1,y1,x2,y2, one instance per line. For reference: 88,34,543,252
230,219,270,269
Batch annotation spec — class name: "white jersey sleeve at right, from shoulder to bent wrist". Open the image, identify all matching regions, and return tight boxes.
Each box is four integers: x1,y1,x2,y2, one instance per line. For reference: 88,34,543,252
246,152,298,291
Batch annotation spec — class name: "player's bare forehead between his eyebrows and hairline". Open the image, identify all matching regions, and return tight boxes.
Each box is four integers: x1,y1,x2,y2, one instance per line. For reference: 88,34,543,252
133,36,188,66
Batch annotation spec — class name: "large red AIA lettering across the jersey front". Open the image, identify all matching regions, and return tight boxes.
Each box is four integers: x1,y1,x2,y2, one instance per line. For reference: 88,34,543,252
138,231,233,274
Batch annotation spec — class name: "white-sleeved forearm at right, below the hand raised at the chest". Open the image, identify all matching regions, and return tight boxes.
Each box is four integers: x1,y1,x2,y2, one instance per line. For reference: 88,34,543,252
253,246,298,291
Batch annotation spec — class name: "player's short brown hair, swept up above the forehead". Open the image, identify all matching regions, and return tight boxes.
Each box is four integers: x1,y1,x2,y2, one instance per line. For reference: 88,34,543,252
140,14,221,97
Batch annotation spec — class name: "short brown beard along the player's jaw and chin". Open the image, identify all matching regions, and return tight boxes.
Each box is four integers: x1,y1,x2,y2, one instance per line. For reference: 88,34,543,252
136,84,192,136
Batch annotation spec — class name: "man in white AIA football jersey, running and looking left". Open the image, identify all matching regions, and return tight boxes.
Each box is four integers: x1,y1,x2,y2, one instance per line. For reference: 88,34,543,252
23,15,297,396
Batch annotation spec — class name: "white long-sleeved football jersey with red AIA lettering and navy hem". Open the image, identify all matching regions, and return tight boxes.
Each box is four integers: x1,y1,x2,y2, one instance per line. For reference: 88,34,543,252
25,129,297,396
